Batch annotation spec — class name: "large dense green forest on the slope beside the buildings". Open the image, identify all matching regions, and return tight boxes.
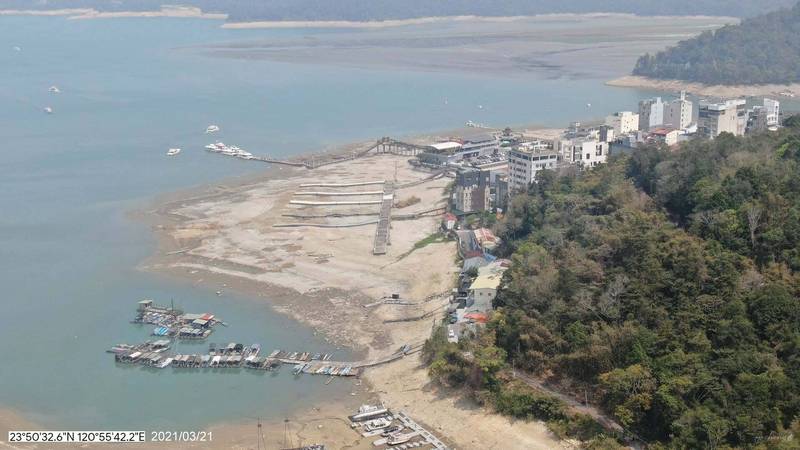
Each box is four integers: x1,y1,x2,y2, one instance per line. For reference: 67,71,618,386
425,119,800,449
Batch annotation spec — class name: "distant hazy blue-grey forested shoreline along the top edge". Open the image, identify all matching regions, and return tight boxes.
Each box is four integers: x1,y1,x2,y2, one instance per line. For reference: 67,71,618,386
0,0,794,21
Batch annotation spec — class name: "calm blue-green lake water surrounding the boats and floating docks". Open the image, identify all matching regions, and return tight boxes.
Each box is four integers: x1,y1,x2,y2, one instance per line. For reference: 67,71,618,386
0,13,740,429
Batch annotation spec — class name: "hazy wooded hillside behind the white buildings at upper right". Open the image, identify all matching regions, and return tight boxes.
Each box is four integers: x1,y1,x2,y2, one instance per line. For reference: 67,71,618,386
633,4,800,84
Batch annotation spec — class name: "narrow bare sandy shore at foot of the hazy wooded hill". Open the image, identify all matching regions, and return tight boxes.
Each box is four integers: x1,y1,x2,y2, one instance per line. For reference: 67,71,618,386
606,75,800,97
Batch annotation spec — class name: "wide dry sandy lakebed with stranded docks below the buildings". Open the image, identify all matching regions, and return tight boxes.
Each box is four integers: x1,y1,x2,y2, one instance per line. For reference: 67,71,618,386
133,130,568,449
